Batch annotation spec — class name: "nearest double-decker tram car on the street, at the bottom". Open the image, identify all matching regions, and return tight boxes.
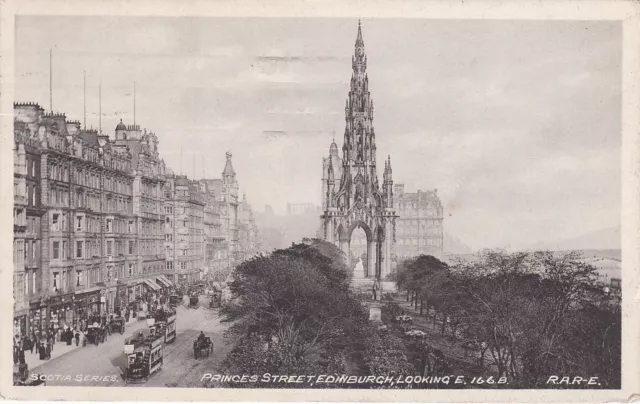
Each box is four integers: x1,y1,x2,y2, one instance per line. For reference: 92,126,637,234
124,319,165,384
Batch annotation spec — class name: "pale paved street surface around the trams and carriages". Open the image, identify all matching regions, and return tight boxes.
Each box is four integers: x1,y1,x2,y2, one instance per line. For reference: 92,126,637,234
27,297,229,387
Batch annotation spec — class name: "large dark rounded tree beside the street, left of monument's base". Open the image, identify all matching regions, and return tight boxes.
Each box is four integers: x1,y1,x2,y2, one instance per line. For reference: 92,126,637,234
222,240,367,371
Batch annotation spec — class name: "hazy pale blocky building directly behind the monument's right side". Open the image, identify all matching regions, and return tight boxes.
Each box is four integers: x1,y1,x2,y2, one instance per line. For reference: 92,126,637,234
394,184,444,259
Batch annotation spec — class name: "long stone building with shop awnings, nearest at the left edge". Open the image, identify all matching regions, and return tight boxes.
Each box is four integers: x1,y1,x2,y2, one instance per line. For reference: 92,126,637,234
14,104,172,333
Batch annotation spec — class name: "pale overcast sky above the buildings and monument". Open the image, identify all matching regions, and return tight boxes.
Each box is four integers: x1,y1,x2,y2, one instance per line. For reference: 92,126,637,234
15,16,621,248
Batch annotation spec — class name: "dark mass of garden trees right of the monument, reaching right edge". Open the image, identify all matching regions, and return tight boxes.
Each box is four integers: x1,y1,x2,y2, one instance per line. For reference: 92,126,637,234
396,250,620,388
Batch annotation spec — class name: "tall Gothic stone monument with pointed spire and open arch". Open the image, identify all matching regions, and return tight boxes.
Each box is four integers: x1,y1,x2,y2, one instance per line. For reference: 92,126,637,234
321,23,396,287
